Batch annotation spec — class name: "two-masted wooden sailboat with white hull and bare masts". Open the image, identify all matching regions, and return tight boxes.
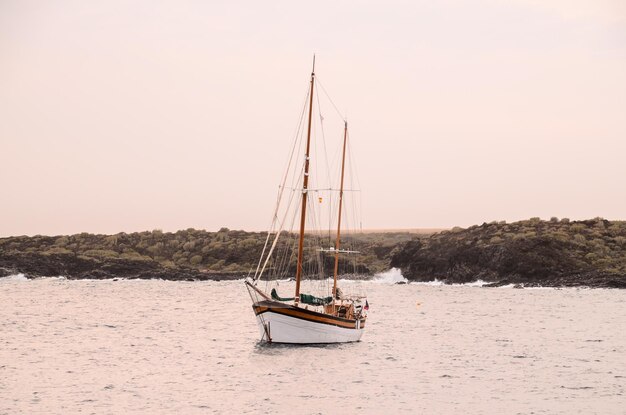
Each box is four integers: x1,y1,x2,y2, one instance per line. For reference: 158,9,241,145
245,57,369,344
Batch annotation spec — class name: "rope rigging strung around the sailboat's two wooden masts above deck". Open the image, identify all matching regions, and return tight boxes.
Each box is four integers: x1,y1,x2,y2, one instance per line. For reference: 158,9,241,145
248,68,361,302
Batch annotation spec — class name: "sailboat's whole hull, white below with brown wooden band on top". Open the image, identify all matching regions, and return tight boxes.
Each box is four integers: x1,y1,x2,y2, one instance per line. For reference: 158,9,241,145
252,301,365,344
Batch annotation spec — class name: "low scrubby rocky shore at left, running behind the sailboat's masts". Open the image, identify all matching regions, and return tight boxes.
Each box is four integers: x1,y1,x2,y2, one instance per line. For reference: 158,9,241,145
0,228,404,281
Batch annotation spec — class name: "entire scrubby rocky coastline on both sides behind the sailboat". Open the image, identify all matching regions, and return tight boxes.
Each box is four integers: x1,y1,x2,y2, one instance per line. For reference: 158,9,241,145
0,218,626,288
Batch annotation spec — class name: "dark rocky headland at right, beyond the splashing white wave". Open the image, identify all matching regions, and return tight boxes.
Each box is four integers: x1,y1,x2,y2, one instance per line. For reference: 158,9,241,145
390,218,626,288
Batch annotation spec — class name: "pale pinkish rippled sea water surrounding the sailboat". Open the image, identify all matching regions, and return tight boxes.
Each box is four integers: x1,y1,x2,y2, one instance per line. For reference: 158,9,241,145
0,275,626,414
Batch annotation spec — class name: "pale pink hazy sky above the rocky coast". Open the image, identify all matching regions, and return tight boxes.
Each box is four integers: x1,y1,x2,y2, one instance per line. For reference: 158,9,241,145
0,0,626,236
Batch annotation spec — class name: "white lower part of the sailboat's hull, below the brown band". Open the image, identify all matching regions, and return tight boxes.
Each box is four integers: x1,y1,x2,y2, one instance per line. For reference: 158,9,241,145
256,312,365,344
